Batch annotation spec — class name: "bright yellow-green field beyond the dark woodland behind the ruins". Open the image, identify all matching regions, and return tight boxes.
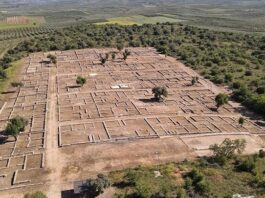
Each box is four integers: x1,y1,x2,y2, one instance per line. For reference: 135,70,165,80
96,15,182,25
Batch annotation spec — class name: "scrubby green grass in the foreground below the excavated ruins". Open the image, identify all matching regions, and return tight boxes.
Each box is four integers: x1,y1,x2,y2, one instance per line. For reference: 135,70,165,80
109,157,265,198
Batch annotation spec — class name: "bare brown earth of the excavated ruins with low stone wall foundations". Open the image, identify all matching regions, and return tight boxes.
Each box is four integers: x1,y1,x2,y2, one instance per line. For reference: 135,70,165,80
0,48,265,198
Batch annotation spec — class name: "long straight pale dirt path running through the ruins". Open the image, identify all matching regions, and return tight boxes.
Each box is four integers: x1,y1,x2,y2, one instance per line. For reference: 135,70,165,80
46,68,62,198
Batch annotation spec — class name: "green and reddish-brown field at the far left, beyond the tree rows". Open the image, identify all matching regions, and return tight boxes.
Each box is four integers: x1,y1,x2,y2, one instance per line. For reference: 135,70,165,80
0,16,45,30
